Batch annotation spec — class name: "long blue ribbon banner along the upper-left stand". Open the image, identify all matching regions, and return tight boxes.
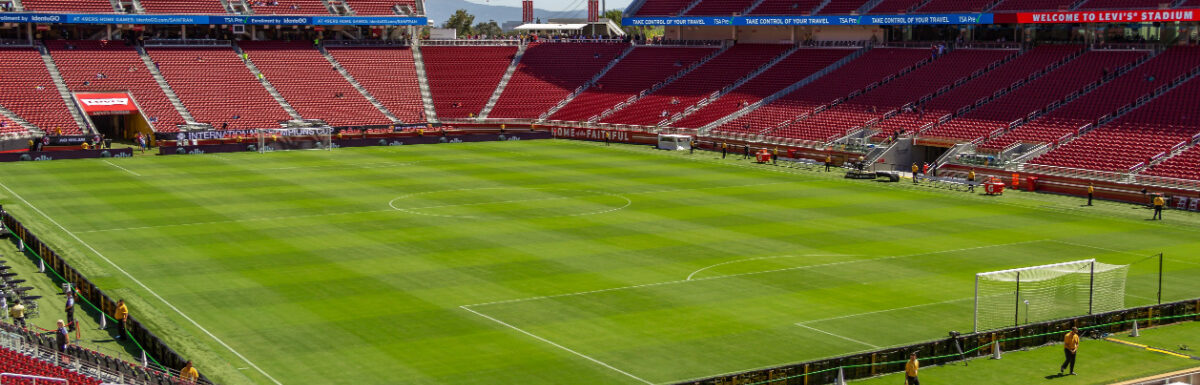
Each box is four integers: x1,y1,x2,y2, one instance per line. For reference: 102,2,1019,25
0,13,428,25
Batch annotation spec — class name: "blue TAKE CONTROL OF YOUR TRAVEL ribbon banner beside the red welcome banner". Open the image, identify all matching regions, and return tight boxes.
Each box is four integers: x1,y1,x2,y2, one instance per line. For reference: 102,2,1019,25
622,13,994,26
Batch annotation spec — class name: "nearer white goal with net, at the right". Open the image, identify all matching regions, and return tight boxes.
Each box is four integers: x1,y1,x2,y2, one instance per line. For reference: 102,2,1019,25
974,259,1129,332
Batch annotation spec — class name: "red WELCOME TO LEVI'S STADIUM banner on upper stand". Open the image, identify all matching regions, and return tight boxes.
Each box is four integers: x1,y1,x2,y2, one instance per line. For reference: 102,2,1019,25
995,10,1200,24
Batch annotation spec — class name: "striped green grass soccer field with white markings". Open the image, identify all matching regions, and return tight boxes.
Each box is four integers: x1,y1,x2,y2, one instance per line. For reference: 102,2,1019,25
0,140,1200,384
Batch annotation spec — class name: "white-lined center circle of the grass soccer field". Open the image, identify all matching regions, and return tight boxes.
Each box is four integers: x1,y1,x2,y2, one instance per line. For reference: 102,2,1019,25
388,187,634,219
